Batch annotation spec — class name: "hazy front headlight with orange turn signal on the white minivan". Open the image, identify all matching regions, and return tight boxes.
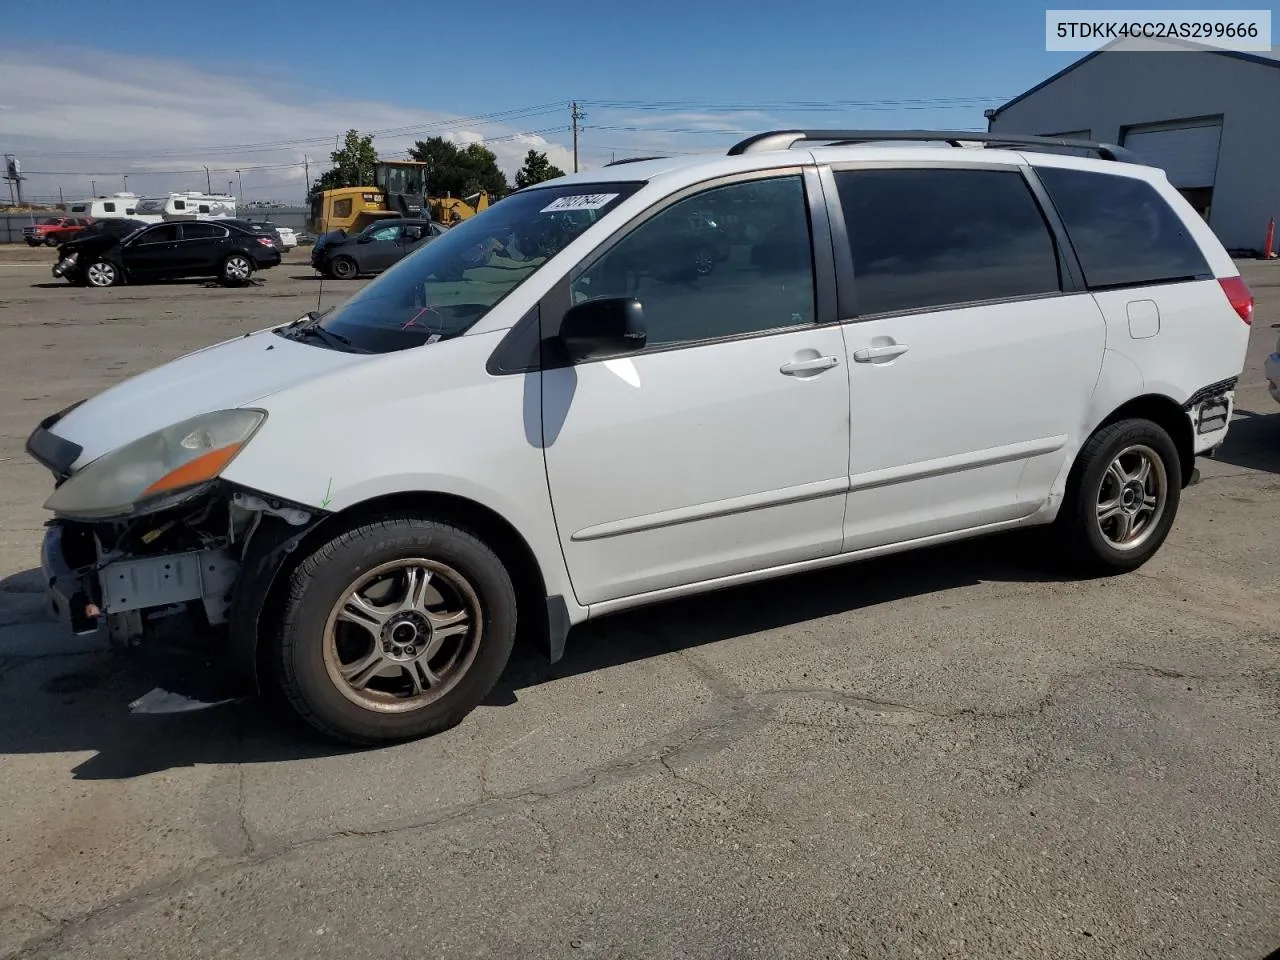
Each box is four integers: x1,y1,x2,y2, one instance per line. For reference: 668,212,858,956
45,410,266,518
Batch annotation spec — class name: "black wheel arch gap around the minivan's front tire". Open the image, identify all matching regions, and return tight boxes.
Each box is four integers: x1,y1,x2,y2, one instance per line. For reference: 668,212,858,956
230,492,558,692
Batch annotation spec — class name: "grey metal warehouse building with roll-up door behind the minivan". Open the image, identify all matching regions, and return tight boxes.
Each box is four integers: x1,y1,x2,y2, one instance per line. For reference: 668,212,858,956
987,41,1280,252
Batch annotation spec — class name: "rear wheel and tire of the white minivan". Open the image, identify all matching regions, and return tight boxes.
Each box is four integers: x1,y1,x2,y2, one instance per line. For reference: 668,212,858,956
1055,419,1181,575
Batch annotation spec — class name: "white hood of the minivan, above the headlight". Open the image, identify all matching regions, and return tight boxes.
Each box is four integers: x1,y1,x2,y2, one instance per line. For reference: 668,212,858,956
50,328,376,470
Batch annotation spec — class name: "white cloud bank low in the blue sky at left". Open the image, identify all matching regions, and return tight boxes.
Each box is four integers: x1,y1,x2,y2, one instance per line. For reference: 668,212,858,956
0,47,572,202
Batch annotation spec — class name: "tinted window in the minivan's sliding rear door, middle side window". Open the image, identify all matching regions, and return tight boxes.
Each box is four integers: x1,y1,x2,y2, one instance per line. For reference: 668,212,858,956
836,169,1061,314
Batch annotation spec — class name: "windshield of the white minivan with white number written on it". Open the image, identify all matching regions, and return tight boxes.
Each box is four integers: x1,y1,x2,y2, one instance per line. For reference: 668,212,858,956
320,183,643,353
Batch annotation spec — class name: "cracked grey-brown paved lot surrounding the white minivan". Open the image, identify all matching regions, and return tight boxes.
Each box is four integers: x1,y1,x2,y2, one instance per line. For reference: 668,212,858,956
0,250,1280,960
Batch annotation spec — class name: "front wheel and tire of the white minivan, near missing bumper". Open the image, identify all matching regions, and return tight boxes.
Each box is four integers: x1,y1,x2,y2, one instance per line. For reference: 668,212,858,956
274,515,516,745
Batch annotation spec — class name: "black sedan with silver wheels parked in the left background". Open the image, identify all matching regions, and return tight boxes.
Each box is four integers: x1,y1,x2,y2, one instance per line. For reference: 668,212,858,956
54,220,280,287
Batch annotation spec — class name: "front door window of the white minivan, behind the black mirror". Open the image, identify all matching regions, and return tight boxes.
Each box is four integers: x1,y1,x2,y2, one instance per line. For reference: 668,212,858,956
572,175,815,346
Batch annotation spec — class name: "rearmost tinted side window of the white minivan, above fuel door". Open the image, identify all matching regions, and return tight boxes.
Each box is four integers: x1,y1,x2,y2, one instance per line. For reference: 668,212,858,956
1036,166,1212,289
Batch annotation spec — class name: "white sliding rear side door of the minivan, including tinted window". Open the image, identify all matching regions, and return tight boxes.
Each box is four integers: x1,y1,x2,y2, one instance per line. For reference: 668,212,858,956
835,166,1106,550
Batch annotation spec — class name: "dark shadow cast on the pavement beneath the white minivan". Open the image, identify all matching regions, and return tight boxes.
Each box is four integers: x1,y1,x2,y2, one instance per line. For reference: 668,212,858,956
0,534,1061,780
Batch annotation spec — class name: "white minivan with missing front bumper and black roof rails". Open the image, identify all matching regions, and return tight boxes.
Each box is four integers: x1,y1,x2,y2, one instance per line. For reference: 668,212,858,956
27,131,1253,744
